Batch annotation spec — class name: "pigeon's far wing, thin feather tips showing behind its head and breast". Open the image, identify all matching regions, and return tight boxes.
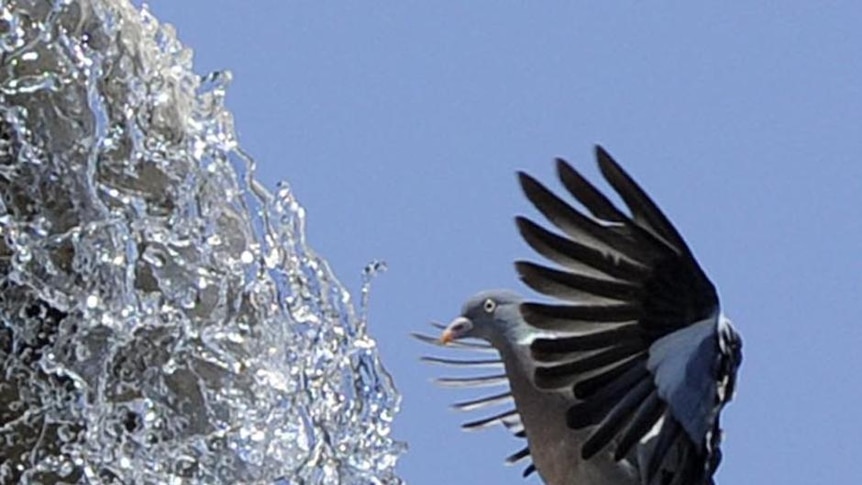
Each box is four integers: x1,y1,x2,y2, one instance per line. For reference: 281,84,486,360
413,325,536,477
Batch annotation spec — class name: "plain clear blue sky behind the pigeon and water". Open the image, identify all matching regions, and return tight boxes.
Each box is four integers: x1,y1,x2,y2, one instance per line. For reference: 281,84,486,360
138,0,862,485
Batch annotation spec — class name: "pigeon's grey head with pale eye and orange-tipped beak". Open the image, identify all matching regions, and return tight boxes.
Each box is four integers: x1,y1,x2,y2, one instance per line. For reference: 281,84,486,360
440,290,524,347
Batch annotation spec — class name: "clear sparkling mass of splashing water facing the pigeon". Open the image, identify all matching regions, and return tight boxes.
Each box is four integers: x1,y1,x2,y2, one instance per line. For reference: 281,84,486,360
0,0,403,484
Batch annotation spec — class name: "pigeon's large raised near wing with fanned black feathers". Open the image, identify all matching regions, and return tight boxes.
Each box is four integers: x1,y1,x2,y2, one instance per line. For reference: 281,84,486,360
516,147,740,484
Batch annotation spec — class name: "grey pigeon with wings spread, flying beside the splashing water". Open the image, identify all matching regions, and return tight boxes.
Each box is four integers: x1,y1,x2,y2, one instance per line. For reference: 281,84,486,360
414,146,742,485
